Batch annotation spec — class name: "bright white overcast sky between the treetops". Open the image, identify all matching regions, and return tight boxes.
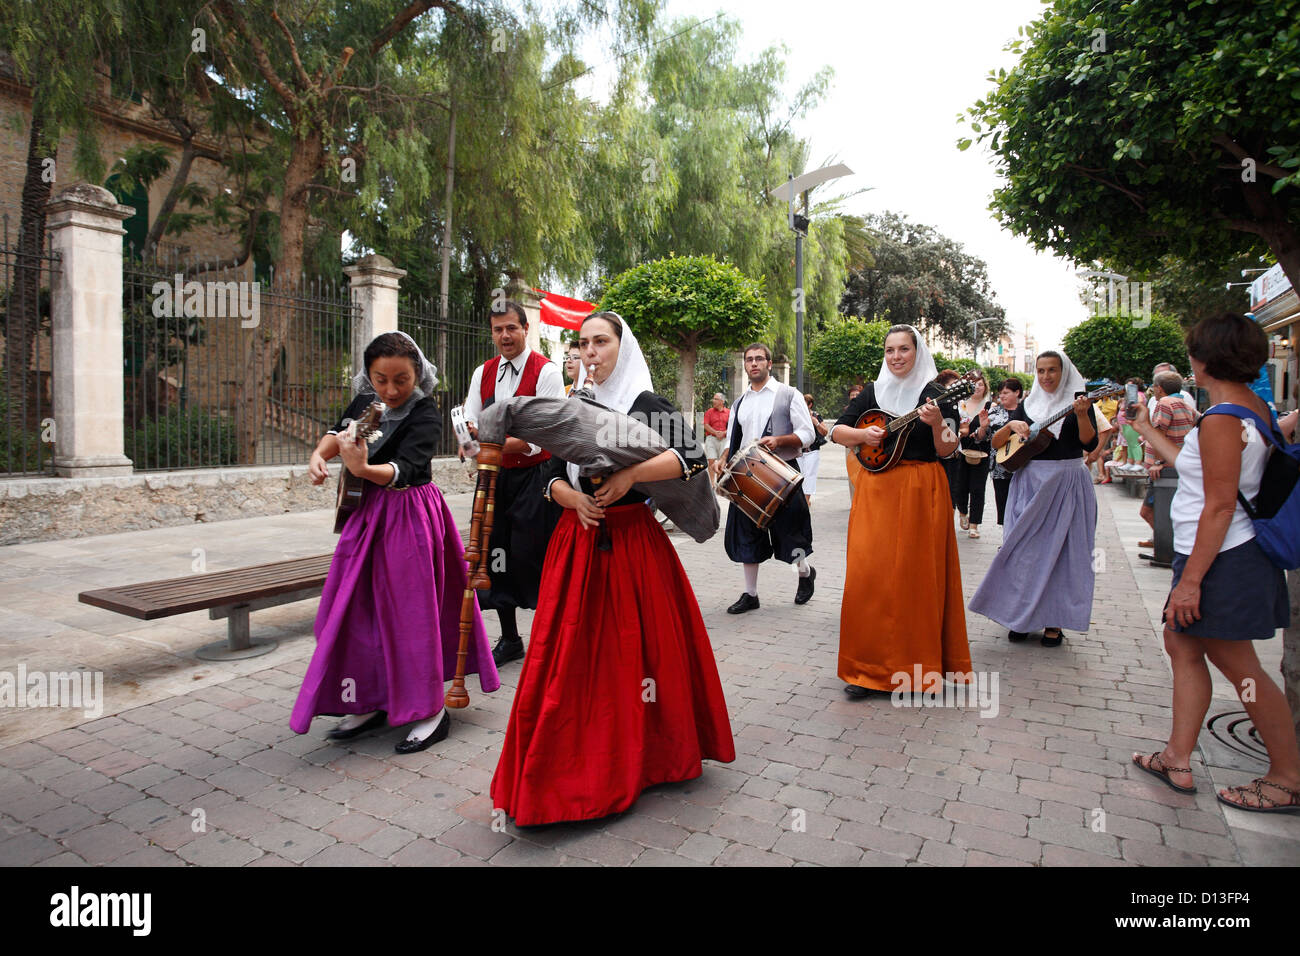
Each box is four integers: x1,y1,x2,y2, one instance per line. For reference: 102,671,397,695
647,0,1087,349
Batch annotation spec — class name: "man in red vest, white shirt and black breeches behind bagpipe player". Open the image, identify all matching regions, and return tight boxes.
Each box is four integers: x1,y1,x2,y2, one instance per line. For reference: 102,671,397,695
465,299,564,667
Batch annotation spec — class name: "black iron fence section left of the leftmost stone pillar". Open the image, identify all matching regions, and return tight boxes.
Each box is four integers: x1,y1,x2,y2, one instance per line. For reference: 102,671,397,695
0,216,59,476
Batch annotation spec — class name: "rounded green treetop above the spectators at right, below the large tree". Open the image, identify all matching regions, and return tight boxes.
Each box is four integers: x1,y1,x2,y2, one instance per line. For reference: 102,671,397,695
1061,313,1190,381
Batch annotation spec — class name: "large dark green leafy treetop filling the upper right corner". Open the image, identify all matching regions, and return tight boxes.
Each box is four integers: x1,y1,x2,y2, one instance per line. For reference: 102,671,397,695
958,0,1300,295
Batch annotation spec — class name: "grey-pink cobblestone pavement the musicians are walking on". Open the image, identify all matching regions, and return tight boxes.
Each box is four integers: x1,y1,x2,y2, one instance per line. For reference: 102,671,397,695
0,446,1300,866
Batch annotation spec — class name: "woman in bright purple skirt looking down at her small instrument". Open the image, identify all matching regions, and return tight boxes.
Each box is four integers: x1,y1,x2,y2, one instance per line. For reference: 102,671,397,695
290,332,501,753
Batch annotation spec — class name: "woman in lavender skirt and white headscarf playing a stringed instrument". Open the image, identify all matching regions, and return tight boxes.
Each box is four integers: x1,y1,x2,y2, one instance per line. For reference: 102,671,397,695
970,351,1097,648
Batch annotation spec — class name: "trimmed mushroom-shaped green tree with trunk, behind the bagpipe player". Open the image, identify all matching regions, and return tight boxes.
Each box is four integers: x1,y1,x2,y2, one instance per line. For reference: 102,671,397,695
601,256,774,421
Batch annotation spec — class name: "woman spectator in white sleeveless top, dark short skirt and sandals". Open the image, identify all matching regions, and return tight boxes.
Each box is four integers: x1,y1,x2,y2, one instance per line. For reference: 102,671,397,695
1132,312,1300,813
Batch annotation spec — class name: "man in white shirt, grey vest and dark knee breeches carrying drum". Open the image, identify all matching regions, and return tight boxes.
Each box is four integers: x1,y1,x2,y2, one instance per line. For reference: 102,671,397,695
723,342,816,614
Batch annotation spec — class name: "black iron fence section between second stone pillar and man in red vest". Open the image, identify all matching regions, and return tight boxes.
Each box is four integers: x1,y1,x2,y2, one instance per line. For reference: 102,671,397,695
398,298,497,455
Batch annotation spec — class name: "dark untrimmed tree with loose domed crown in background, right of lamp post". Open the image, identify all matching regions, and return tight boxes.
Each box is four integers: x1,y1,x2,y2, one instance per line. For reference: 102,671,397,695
840,212,1006,345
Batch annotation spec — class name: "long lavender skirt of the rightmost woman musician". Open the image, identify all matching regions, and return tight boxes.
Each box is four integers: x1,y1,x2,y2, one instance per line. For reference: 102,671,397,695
970,458,1097,632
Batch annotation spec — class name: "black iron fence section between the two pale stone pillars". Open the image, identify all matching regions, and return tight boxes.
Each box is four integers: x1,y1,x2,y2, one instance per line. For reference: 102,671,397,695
122,250,356,471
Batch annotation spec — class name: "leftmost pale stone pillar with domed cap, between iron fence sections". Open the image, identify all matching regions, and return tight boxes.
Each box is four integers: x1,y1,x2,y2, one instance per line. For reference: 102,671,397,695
46,182,135,477
